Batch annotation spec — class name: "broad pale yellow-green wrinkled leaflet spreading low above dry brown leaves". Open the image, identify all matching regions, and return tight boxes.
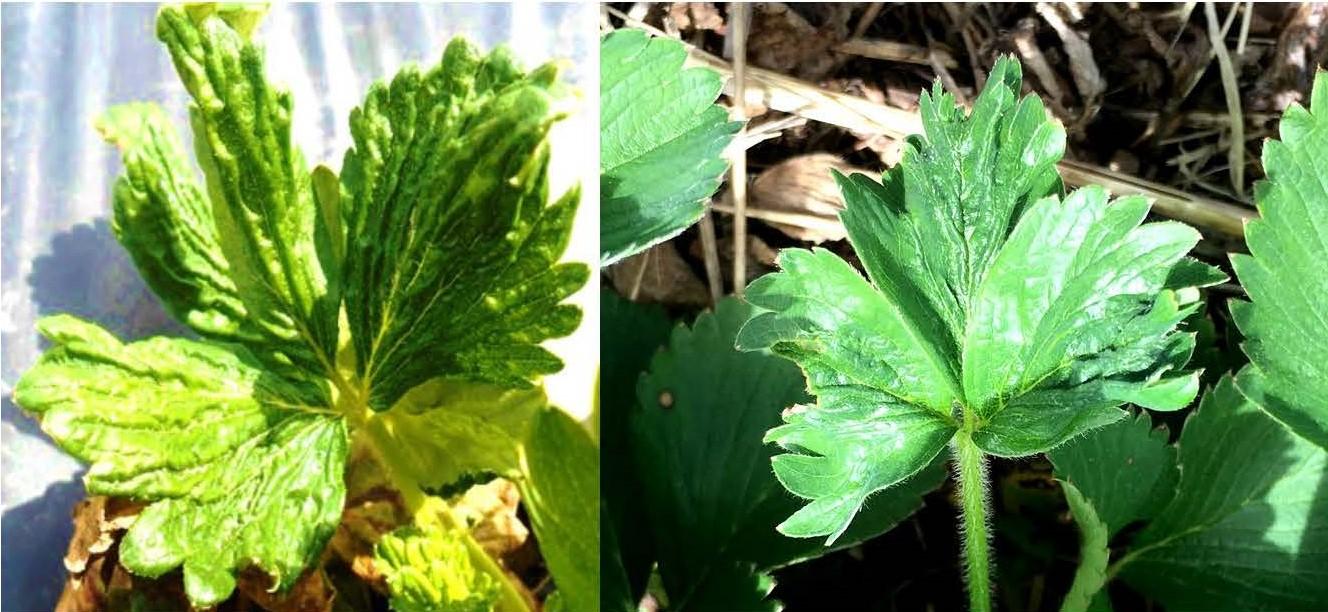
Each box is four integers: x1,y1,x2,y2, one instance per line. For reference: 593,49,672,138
15,316,348,605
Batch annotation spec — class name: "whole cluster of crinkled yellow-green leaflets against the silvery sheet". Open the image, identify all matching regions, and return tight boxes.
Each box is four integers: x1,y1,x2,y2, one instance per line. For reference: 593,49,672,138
15,4,594,609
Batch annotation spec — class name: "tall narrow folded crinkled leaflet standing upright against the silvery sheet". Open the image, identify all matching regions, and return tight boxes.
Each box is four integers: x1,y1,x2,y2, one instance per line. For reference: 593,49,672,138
157,5,340,373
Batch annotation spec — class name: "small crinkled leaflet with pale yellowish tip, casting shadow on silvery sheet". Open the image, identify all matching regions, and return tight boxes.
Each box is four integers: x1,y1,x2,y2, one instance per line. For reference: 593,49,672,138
97,104,262,344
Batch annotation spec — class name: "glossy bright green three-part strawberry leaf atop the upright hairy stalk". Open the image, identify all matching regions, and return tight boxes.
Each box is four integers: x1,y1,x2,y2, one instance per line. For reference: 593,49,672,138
738,58,1220,544
